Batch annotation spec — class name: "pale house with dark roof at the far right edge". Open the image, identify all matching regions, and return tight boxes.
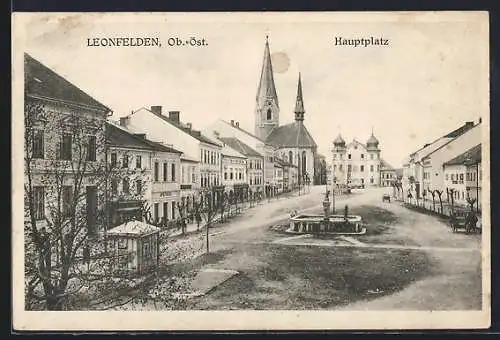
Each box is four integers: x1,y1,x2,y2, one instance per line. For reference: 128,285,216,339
443,144,482,209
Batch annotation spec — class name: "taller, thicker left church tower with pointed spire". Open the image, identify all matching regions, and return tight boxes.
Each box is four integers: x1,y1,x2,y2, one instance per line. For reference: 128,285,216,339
254,36,280,140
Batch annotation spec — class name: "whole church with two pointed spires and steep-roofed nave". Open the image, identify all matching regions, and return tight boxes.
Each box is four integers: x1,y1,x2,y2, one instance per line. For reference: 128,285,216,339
254,37,317,183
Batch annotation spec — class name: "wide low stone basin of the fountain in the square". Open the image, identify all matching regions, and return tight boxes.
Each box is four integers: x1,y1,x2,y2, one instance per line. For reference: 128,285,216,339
287,214,366,235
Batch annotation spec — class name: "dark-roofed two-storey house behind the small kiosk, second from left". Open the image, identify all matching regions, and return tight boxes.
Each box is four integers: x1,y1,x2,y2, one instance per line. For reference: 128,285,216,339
106,124,182,226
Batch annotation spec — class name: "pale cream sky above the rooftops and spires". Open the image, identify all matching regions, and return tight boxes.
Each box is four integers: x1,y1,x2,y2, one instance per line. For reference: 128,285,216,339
19,13,489,167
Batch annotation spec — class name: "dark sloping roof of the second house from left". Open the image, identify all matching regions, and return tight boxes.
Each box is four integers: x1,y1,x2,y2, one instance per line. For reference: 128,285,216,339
106,123,182,154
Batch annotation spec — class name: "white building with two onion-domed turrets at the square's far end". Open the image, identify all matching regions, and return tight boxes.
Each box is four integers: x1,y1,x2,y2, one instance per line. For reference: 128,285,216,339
332,133,381,187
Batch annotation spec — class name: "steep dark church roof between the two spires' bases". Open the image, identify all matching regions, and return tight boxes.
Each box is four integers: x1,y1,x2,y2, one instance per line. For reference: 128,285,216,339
266,122,317,148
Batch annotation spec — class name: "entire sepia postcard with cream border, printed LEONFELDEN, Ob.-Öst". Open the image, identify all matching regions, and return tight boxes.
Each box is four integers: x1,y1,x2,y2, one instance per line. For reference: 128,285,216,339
12,12,491,330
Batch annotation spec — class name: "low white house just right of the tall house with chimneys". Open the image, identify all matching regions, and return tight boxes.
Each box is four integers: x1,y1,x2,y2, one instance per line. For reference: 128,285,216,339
221,140,248,200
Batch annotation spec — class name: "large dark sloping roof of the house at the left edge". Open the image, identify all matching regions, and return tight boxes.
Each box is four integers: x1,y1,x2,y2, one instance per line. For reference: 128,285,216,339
24,53,111,112
